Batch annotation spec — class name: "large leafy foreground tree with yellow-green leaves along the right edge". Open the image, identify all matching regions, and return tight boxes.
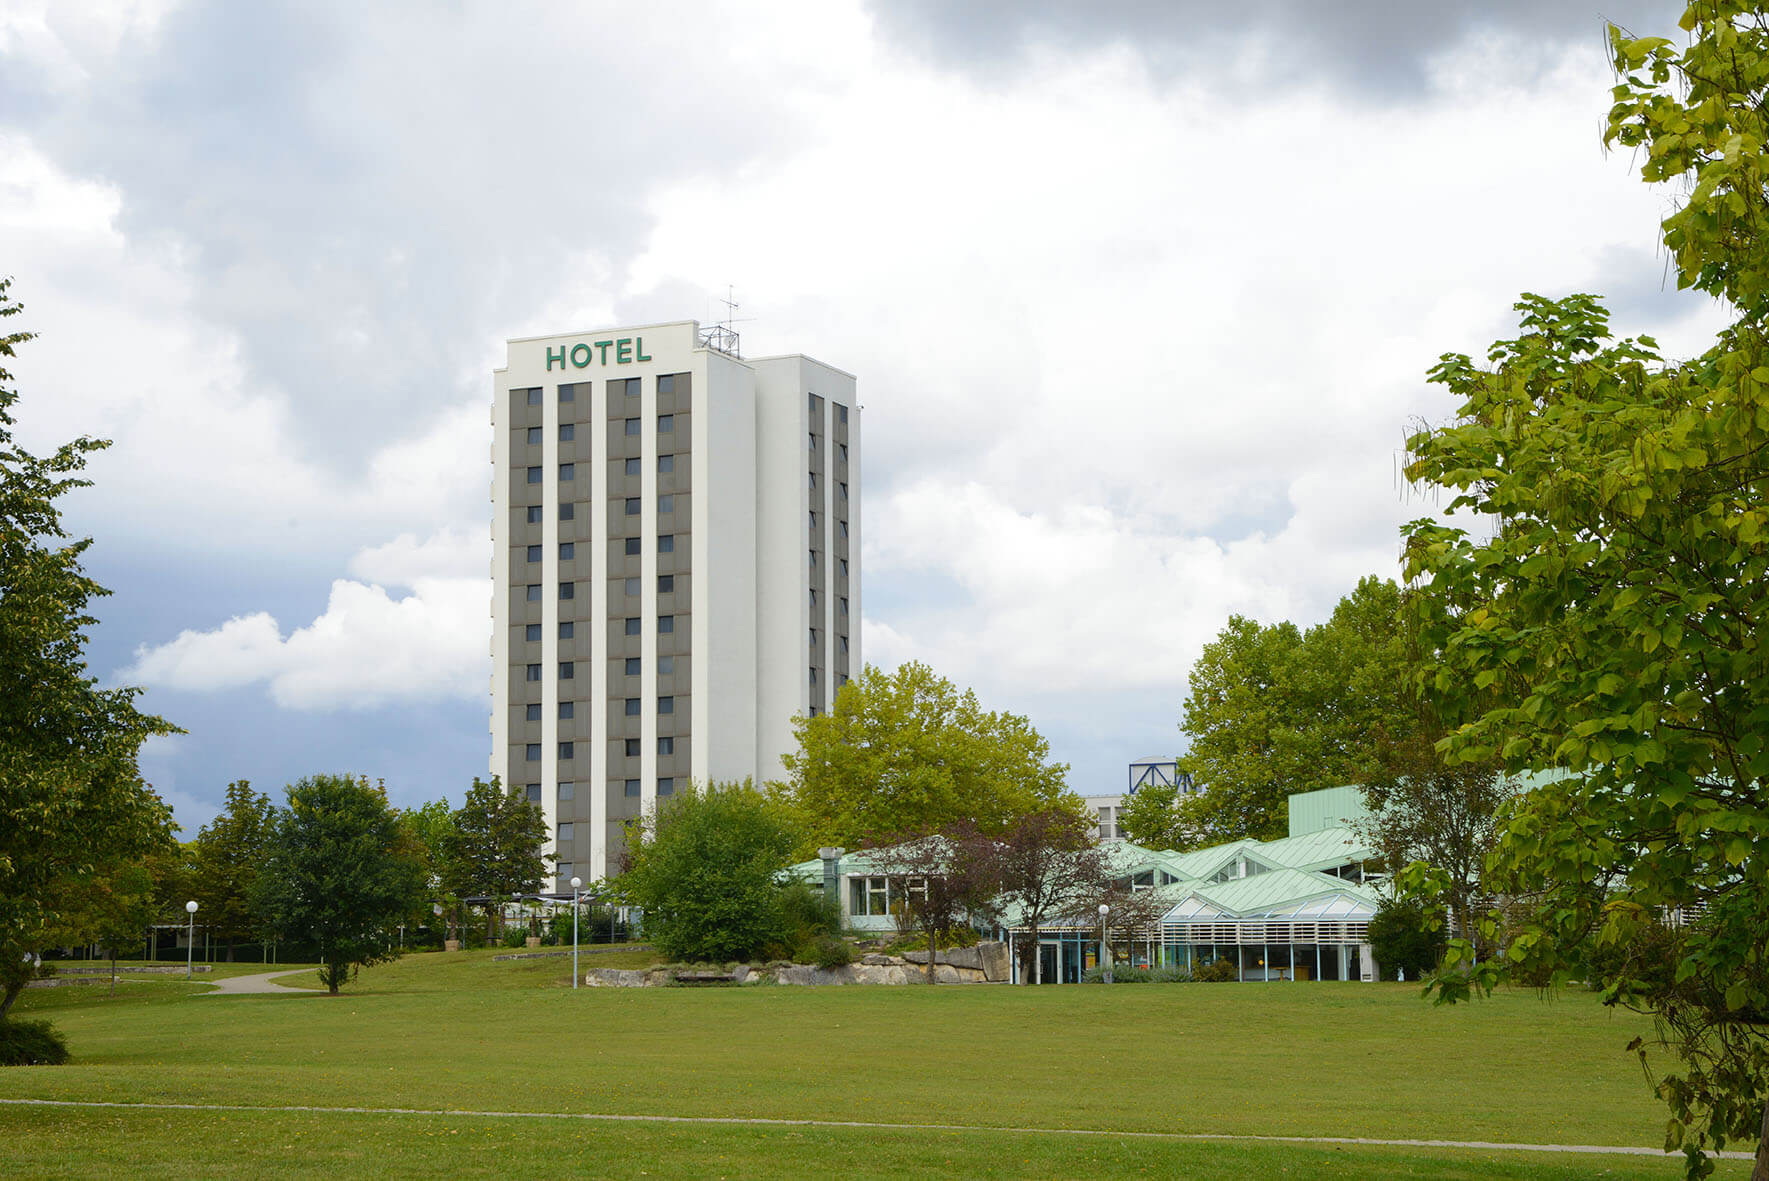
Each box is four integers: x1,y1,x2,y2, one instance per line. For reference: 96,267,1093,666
1406,9,1769,1181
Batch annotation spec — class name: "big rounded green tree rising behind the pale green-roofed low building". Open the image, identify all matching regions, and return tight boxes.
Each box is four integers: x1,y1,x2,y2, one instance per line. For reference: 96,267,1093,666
1174,576,1410,849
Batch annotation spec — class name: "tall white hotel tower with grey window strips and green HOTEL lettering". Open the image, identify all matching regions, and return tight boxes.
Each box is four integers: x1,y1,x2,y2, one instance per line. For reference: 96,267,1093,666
490,320,860,880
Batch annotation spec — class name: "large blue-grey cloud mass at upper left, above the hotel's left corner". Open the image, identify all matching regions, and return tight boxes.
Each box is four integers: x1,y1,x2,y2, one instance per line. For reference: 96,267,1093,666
0,0,810,470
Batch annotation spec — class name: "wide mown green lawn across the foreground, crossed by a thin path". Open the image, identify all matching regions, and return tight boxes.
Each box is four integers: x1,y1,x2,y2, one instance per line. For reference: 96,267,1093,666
0,953,1748,1177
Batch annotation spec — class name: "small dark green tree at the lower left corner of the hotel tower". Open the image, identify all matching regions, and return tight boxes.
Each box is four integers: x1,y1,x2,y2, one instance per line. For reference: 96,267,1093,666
439,774,547,939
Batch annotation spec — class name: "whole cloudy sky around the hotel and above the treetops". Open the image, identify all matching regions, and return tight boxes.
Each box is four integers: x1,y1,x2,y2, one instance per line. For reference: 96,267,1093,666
0,0,1719,833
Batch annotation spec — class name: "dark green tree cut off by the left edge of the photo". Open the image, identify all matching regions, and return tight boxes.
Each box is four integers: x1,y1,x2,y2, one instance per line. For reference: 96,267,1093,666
0,279,175,1018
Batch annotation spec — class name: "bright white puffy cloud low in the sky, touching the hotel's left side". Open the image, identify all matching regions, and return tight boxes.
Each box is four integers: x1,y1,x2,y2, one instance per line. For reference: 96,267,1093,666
117,532,492,711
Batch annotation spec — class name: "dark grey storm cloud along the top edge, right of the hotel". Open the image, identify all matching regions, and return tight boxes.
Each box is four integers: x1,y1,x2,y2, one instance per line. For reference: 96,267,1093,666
869,0,1682,101
